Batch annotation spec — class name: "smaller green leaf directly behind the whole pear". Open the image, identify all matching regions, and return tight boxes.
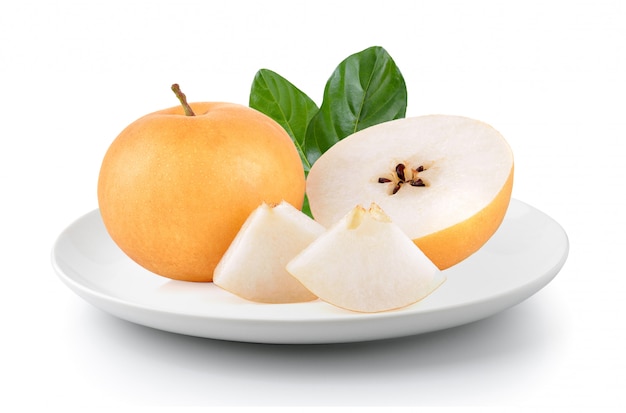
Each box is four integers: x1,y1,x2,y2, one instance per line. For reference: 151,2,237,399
249,69,318,173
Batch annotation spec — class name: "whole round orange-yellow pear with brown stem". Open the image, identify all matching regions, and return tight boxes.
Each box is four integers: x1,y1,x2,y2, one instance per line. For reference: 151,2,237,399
97,84,305,282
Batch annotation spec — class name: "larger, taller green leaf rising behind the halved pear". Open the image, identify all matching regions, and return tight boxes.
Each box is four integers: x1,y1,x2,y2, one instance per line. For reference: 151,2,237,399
304,46,407,165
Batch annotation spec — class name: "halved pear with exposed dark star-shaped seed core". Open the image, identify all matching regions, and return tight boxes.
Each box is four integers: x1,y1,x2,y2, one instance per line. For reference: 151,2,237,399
307,115,513,270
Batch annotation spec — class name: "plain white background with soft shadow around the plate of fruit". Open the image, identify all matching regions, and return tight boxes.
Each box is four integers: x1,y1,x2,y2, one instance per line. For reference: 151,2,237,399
0,0,626,410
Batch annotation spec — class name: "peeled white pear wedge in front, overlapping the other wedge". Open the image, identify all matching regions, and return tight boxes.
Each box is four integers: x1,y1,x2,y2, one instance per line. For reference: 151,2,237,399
287,204,445,313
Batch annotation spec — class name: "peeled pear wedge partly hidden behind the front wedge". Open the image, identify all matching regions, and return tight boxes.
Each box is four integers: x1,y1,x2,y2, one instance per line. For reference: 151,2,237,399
213,202,325,303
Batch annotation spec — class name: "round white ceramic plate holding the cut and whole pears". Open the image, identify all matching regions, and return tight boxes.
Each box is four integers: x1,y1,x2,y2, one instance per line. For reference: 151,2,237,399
52,199,569,344
